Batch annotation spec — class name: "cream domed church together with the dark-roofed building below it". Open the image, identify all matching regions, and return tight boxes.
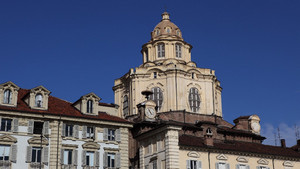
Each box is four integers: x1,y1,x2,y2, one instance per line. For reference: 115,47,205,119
113,12,300,169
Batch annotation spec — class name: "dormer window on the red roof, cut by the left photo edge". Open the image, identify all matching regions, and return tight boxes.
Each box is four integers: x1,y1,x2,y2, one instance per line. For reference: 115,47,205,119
0,81,20,107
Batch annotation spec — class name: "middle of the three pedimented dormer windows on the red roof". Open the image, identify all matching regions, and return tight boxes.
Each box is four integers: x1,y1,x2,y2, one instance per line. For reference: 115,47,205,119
24,86,51,110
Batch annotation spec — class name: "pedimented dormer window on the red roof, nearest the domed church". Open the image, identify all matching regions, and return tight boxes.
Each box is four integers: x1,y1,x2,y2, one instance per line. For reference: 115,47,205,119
73,93,101,115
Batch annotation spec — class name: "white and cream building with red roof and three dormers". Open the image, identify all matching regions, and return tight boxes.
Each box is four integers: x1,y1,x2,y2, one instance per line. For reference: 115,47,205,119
0,82,132,169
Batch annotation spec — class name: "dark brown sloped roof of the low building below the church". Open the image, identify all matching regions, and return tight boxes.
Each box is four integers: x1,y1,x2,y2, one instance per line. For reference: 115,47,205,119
179,135,300,158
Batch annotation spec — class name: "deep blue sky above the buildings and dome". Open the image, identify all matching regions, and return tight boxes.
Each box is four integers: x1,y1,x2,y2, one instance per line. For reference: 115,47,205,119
0,0,300,145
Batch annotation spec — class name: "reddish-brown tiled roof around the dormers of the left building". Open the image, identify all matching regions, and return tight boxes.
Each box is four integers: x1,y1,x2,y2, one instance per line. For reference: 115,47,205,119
0,89,131,123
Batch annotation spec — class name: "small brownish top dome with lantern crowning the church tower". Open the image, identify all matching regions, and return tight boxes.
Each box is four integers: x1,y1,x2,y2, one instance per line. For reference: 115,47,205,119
151,12,182,40
